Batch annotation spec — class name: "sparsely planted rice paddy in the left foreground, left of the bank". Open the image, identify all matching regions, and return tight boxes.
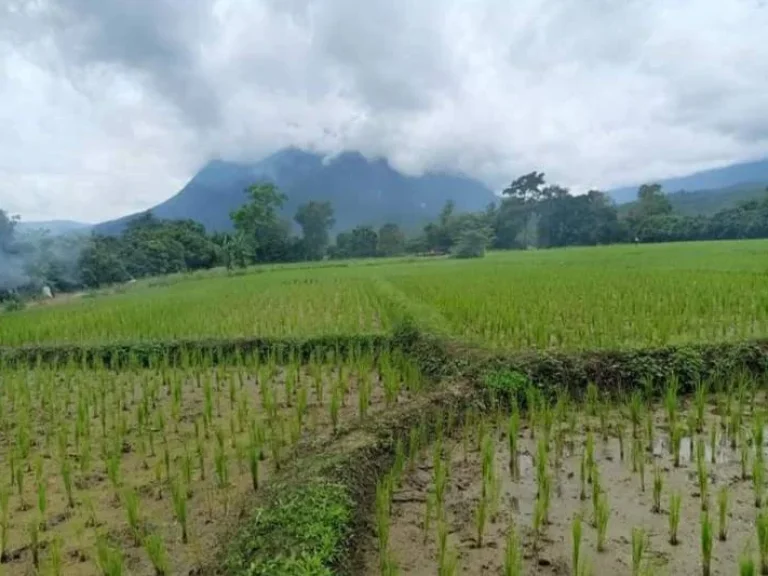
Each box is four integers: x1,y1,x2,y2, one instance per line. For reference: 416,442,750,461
0,353,423,575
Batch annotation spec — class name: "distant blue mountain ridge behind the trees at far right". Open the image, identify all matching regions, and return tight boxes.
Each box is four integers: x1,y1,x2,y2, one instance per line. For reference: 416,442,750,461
609,159,768,204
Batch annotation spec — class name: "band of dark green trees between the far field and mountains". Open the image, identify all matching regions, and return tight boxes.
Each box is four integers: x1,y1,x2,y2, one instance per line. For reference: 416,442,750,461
0,172,768,299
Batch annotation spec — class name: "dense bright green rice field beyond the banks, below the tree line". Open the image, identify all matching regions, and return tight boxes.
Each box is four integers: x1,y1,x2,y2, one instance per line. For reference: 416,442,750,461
0,241,768,350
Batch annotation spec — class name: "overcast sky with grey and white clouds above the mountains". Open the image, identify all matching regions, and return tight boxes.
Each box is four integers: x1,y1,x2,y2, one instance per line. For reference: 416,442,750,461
0,0,768,222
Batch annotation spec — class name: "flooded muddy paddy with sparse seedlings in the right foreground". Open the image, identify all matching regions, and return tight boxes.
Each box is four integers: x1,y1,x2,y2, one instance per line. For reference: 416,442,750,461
364,378,768,576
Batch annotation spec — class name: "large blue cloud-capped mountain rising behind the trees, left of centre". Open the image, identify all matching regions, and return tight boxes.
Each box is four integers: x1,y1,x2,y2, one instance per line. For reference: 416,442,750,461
96,148,494,234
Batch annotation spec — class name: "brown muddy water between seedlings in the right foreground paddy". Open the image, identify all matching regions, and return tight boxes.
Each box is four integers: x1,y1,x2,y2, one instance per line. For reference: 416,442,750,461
365,404,768,576
